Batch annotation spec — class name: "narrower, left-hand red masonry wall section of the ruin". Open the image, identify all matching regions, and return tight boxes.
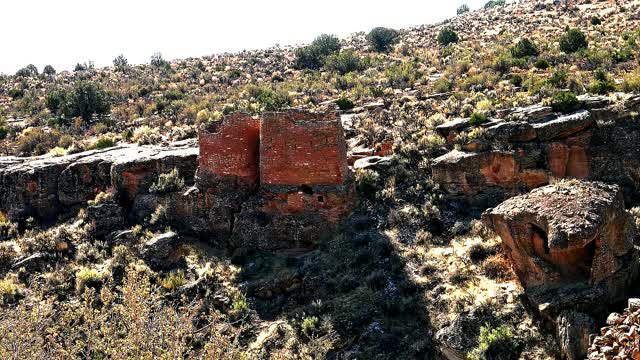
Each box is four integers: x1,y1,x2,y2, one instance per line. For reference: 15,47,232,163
198,113,260,183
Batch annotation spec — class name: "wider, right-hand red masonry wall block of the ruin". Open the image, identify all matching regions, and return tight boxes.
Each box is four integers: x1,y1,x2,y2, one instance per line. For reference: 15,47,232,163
260,111,348,185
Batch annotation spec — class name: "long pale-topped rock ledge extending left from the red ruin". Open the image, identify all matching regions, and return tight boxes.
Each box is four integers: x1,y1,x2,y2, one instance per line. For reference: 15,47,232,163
0,142,198,220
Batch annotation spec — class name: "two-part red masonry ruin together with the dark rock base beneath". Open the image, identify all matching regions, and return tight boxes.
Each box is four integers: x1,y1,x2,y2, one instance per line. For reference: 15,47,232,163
196,111,355,248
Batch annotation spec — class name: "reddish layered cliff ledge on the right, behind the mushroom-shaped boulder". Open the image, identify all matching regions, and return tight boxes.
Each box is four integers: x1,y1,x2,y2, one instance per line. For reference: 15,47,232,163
432,96,640,208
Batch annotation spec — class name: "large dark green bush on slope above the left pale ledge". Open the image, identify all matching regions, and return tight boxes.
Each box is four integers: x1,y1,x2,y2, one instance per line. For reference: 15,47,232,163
45,80,111,120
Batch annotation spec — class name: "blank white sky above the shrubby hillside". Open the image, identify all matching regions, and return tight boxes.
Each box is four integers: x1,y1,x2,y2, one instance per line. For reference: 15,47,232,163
0,0,487,74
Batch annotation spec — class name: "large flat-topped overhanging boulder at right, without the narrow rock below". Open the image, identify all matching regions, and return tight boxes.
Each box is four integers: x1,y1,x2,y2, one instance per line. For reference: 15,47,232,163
483,181,638,302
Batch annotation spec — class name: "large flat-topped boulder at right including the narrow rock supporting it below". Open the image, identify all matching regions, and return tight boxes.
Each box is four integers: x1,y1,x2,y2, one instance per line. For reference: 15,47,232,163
482,180,638,359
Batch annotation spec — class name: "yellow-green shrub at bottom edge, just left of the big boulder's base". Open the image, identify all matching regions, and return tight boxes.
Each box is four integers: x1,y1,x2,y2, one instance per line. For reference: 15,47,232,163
469,324,522,360
